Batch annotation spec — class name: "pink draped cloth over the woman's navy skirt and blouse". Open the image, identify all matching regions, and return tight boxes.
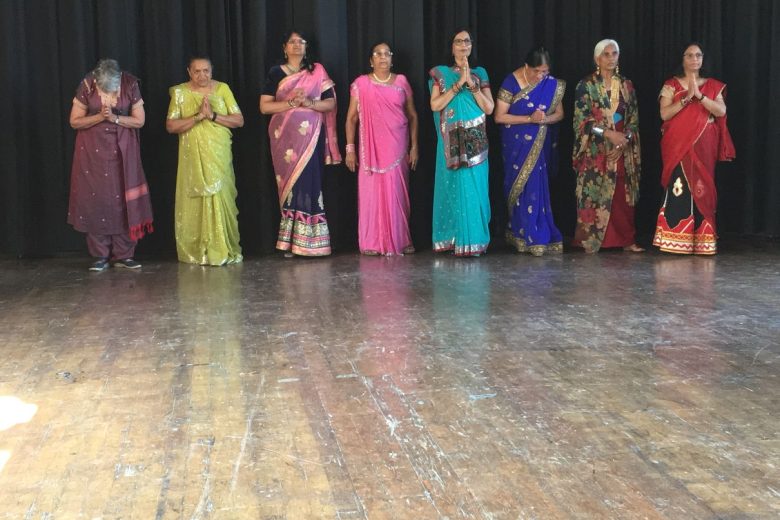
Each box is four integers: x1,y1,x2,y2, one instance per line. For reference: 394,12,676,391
268,63,341,205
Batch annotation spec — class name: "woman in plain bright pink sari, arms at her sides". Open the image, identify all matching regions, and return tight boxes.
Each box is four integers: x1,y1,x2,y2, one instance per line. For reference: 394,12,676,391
346,42,417,255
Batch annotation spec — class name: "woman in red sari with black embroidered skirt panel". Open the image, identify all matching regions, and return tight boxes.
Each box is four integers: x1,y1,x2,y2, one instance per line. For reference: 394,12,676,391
653,43,735,255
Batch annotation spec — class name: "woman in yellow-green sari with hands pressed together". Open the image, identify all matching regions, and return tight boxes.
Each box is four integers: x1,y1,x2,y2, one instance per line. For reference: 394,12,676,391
165,56,244,265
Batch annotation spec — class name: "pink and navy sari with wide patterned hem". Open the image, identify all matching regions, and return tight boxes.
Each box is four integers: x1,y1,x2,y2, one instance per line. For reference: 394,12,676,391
266,63,341,256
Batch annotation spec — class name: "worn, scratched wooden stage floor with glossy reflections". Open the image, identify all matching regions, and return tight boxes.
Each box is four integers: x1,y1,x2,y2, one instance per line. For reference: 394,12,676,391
0,242,780,520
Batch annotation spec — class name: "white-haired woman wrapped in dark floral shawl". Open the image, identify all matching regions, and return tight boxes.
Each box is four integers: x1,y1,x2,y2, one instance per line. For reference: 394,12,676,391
572,39,644,253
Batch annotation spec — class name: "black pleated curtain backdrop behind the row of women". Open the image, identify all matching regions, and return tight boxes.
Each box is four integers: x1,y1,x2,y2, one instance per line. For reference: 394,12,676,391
0,0,780,256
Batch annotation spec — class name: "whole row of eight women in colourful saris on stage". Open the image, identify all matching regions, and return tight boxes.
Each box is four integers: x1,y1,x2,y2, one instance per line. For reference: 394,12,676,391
68,29,734,271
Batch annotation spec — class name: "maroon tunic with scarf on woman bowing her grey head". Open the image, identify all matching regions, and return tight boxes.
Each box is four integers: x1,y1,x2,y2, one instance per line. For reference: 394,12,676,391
68,72,152,243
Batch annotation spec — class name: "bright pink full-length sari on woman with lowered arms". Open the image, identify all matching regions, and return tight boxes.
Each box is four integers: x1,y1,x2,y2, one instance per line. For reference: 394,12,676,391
350,74,413,255
